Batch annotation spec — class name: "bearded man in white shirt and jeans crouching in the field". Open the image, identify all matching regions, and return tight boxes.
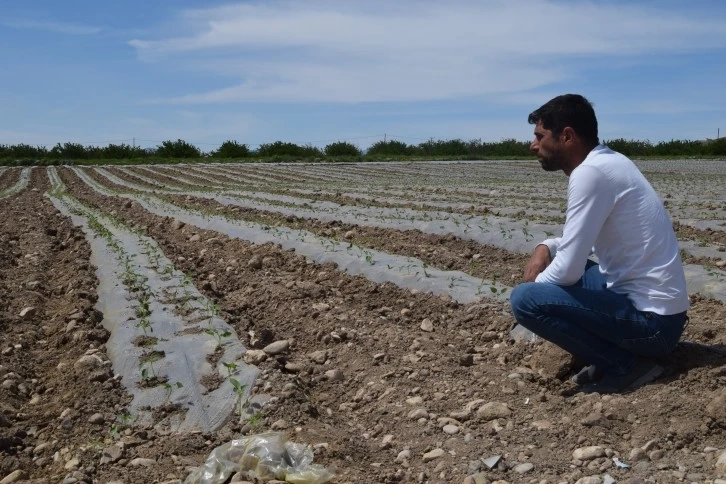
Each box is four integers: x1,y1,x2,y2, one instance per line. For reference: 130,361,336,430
511,94,689,393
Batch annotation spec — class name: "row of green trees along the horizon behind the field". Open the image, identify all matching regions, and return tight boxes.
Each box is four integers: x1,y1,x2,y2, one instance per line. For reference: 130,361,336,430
0,138,726,165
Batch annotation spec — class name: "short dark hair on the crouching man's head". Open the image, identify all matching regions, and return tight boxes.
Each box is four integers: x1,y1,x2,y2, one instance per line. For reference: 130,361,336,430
527,94,599,145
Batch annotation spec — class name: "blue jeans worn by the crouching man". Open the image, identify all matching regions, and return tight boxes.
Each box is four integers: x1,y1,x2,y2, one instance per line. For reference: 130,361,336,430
510,261,687,375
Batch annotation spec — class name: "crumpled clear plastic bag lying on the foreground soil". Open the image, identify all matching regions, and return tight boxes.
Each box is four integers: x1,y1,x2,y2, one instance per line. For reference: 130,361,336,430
184,432,335,484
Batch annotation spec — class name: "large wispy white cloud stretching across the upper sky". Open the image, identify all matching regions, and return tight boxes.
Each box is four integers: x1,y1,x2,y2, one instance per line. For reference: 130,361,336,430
130,0,726,104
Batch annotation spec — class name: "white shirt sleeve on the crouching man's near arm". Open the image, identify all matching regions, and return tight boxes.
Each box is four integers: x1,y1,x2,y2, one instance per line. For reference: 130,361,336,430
536,165,615,286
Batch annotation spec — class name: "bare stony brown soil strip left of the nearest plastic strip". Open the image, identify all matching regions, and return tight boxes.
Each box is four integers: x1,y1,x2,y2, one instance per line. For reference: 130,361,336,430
0,168,128,482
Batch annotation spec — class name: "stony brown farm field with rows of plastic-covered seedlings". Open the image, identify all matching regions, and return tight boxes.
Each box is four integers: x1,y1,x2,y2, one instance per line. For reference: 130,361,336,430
0,160,726,483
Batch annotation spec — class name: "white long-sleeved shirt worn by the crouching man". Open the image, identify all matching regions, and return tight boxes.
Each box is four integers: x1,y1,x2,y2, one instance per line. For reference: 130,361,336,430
536,145,689,315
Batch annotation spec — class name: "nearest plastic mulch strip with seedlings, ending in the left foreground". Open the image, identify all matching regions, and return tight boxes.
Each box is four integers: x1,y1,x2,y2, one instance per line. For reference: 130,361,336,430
48,168,259,432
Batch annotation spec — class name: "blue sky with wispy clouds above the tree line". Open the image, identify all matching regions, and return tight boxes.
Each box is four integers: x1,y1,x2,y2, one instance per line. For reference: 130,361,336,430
0,0,726,151
